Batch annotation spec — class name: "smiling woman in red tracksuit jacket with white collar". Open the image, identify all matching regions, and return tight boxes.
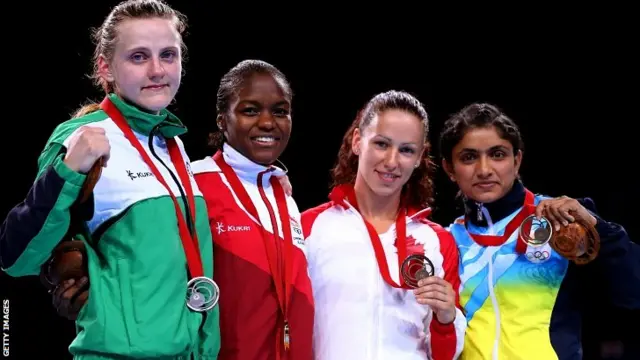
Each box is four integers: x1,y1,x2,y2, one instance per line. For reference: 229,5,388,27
191,60,314,360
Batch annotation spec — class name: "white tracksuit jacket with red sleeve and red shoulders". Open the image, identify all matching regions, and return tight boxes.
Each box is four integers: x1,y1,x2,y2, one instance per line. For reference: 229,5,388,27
302,185,466,360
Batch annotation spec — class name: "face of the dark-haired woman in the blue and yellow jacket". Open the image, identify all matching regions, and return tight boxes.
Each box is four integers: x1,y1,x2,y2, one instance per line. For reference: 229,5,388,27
442,126,522,203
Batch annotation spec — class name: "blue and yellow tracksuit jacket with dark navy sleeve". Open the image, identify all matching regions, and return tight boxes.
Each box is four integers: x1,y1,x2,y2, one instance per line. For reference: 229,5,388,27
449,182,640,360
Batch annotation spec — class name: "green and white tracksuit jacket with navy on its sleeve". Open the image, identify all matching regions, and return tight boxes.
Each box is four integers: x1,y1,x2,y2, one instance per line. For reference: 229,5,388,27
0,94,220,359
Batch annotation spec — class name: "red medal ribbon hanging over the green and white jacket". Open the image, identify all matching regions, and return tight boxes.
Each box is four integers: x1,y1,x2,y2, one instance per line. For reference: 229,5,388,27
100,98,204,278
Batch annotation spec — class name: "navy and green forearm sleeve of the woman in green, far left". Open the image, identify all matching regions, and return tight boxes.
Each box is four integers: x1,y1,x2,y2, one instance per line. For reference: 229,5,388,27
0,155,85,276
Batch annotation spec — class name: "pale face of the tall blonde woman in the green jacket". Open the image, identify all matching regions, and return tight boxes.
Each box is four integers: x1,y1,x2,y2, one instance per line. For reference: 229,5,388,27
98,18,182,112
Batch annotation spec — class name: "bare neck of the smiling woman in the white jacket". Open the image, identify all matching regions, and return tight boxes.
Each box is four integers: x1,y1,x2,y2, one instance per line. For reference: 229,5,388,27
353,176,400,221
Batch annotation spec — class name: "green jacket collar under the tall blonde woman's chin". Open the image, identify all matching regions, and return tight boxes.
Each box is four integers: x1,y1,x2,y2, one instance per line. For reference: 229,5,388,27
107,93,187,138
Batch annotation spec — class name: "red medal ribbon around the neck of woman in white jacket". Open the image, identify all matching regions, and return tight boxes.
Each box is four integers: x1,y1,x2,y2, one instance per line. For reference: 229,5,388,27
330,188,412,289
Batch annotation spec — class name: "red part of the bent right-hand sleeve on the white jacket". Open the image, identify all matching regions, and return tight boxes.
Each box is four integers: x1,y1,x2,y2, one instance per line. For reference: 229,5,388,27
428,221,466,360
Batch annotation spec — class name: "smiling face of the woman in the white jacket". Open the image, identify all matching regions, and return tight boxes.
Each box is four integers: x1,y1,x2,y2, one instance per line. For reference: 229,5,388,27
352,109,424,197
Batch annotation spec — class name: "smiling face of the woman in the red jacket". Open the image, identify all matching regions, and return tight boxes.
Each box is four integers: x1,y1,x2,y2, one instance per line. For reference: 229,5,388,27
218,73,291,165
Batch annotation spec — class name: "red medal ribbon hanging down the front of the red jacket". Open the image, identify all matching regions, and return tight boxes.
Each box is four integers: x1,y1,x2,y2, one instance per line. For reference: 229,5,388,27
213,151,293,359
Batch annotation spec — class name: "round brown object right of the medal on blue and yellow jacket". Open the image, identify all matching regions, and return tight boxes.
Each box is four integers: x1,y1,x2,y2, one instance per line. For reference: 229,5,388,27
550,220,600,265
